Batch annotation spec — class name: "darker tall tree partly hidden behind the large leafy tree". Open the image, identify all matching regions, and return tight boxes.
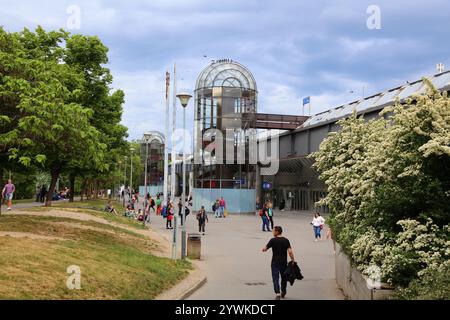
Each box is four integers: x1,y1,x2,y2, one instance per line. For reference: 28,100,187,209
64,35,128,201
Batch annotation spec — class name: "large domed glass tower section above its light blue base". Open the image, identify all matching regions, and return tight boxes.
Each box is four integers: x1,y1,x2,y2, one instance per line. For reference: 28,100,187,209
194,60,257,189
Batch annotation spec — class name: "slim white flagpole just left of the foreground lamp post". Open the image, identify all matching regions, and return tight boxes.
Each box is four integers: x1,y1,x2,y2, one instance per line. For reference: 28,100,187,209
170,64,178,260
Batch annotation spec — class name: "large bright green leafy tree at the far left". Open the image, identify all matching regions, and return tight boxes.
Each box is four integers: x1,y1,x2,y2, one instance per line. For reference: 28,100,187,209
0,27,119,205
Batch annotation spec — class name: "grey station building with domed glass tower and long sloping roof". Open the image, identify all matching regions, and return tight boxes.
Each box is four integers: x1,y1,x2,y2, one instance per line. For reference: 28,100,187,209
170,59,450,213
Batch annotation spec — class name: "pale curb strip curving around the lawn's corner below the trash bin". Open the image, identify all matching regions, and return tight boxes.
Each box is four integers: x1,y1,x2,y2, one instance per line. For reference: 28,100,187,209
155,260,207,300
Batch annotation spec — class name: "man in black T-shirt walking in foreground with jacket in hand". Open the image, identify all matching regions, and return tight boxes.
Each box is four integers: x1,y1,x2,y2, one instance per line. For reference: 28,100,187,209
262,226,295,300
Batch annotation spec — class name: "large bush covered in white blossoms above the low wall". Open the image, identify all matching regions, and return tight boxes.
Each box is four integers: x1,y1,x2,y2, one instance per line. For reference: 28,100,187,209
312,79,450,298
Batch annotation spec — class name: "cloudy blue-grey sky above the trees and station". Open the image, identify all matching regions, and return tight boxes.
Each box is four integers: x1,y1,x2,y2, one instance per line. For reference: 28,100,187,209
0,0,450,140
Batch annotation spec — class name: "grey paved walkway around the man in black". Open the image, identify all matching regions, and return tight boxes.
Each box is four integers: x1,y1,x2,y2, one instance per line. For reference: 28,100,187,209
151,212,344,300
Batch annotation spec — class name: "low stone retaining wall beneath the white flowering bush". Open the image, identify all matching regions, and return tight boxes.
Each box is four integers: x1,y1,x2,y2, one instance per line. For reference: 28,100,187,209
335,243,393,300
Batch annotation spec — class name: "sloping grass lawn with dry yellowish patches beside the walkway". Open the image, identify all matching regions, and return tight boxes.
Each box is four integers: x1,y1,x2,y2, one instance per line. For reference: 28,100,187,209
0,209,190,299
